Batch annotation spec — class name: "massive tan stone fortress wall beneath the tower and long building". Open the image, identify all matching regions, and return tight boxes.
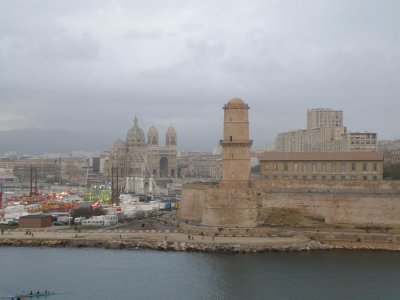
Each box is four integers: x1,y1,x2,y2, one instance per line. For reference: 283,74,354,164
178,180,400,227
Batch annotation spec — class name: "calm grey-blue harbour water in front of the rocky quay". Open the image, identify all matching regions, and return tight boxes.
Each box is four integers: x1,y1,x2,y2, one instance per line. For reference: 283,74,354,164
0,248,400,300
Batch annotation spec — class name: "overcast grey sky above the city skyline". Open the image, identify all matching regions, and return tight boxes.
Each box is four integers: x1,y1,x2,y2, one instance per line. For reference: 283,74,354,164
0,0,400,150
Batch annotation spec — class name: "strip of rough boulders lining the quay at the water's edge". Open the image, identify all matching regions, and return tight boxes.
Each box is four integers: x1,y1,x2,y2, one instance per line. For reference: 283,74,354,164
0,238,333,253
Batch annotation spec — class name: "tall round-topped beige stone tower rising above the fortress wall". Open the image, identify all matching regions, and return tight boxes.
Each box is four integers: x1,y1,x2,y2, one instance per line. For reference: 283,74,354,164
220,98,253,181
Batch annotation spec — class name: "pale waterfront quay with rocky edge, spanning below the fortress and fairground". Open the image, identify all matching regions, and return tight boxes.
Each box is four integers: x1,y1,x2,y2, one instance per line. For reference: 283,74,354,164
0,215,400,253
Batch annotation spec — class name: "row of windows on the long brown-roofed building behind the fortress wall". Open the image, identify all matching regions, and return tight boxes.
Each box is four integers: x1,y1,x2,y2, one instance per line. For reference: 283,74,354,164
264,162,378,173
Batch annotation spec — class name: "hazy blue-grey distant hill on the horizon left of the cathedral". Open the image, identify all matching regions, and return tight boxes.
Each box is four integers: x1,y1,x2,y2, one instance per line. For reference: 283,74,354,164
0,129,115,154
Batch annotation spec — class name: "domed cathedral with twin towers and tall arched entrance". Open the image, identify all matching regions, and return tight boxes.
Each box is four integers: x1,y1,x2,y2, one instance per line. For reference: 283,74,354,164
107,117,177,186
